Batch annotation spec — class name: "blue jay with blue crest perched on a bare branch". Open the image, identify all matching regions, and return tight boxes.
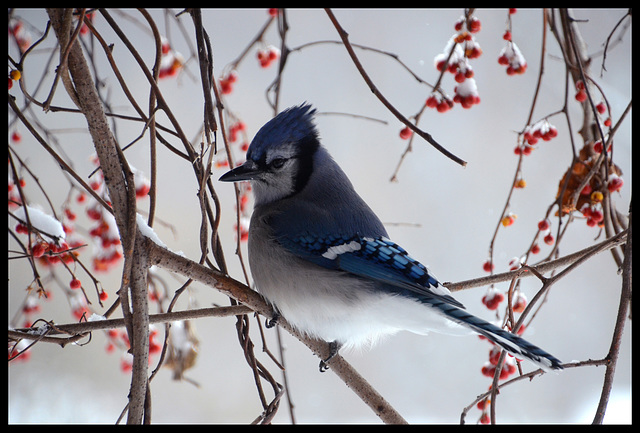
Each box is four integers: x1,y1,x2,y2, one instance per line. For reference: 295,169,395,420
220,104,562,371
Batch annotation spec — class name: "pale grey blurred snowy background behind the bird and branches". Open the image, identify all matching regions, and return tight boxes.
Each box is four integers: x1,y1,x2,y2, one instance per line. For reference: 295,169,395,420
8,9,632,424
